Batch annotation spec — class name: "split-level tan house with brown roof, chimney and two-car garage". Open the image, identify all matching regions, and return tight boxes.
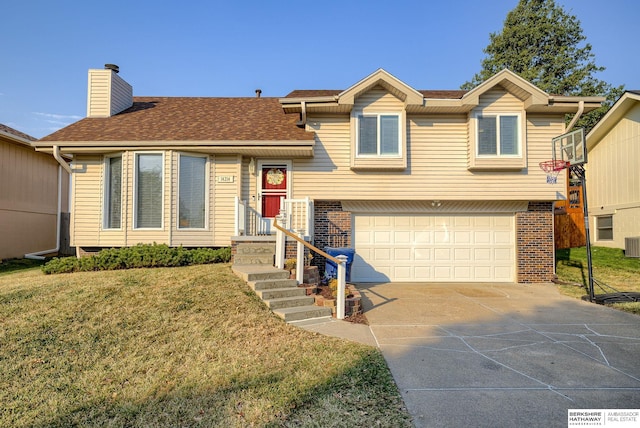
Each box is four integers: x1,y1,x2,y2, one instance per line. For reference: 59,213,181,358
36,66,602,283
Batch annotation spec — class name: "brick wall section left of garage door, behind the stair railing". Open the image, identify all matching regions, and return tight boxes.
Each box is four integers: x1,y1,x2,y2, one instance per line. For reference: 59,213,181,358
312,201,351,275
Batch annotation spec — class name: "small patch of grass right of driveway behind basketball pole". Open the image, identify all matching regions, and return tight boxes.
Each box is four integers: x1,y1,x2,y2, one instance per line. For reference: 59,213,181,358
556,247,640,315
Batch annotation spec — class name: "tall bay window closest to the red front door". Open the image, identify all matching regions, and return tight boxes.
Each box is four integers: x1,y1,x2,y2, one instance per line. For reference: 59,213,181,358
178,154,207,229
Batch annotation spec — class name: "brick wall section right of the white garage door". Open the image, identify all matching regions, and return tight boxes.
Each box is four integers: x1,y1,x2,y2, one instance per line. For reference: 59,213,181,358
516,202,555,283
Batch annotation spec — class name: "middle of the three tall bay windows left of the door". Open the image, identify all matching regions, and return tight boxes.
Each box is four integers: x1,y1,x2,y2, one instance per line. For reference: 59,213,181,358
134,153,164,229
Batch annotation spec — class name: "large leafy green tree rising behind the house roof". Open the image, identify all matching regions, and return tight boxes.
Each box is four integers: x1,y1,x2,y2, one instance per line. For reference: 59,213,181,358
462,0,624,132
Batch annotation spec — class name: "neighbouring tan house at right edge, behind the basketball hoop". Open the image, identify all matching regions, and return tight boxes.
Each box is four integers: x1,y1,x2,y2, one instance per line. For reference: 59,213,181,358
586,91,640,251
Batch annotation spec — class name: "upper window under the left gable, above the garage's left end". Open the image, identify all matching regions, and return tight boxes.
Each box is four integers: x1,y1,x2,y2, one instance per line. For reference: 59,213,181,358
357,114,402,157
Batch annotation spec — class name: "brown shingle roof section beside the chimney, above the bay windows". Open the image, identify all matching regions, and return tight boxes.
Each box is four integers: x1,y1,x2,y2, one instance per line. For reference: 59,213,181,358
40,97,314,142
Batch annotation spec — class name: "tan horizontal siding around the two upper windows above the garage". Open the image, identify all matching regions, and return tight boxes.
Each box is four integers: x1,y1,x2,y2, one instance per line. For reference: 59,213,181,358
293,114,564,200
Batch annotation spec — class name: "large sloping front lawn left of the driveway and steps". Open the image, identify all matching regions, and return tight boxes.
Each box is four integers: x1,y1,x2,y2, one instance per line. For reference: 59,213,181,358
0,264,410,427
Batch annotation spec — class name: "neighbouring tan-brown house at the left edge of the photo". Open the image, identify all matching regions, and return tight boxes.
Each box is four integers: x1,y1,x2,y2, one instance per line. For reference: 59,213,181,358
0,124,69,260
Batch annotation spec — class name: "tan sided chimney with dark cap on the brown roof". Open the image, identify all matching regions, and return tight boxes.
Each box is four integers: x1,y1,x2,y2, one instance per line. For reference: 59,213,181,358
87,64,133,117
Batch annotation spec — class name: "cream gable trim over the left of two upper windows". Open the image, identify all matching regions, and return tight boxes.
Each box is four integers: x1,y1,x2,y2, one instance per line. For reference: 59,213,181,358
338,68,424,105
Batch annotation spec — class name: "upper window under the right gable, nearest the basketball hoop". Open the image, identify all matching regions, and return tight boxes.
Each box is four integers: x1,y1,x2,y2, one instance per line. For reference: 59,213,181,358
477,114,521,156
